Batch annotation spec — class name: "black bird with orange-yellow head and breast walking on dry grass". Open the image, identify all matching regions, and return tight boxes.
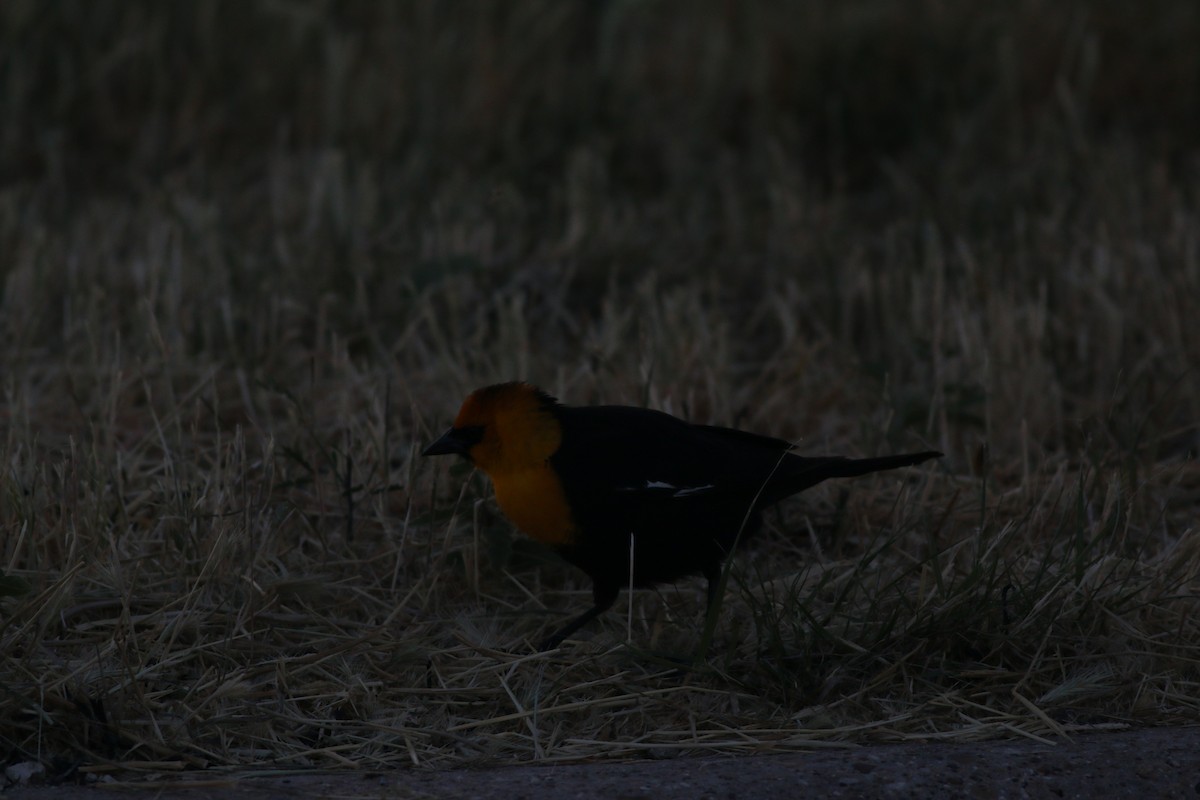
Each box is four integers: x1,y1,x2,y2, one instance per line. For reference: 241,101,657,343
422,381,942,651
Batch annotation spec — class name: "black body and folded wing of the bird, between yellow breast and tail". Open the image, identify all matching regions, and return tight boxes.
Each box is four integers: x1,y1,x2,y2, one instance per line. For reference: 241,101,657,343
551,405,790,584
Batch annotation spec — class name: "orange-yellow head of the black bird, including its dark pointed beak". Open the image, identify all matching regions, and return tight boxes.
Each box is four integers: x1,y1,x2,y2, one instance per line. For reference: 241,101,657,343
421,383,563,479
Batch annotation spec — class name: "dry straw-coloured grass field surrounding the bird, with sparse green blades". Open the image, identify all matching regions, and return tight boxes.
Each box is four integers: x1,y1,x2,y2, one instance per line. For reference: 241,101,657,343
0,0,1200,780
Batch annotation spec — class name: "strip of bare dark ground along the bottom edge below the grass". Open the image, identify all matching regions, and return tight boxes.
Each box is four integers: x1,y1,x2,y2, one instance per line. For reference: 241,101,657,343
4,727,1200,800
